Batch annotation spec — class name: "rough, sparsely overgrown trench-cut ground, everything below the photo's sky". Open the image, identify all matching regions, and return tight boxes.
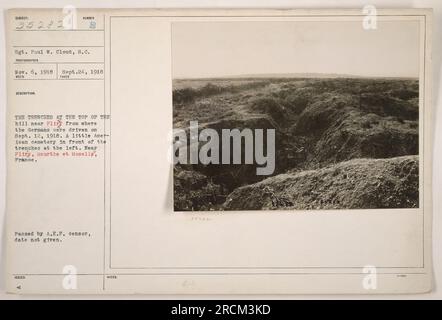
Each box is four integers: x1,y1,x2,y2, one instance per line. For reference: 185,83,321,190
173,78,419,211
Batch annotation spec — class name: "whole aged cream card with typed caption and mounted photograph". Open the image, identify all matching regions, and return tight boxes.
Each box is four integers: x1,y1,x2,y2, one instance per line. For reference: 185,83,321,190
2,8,432,294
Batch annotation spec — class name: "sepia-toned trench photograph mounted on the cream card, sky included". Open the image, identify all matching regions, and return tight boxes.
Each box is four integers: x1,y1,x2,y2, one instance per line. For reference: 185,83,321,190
172,20,420,211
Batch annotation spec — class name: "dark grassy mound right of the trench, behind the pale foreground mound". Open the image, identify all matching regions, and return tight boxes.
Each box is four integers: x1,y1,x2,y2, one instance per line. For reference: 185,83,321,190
294,93,419,166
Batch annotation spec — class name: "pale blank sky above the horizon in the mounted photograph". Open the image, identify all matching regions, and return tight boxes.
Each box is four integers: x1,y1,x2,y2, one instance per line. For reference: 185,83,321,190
172,21,419,78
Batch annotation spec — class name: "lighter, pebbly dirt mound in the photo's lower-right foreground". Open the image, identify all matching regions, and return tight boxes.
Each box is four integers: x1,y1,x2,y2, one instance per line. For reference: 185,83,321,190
223,156,419,210
